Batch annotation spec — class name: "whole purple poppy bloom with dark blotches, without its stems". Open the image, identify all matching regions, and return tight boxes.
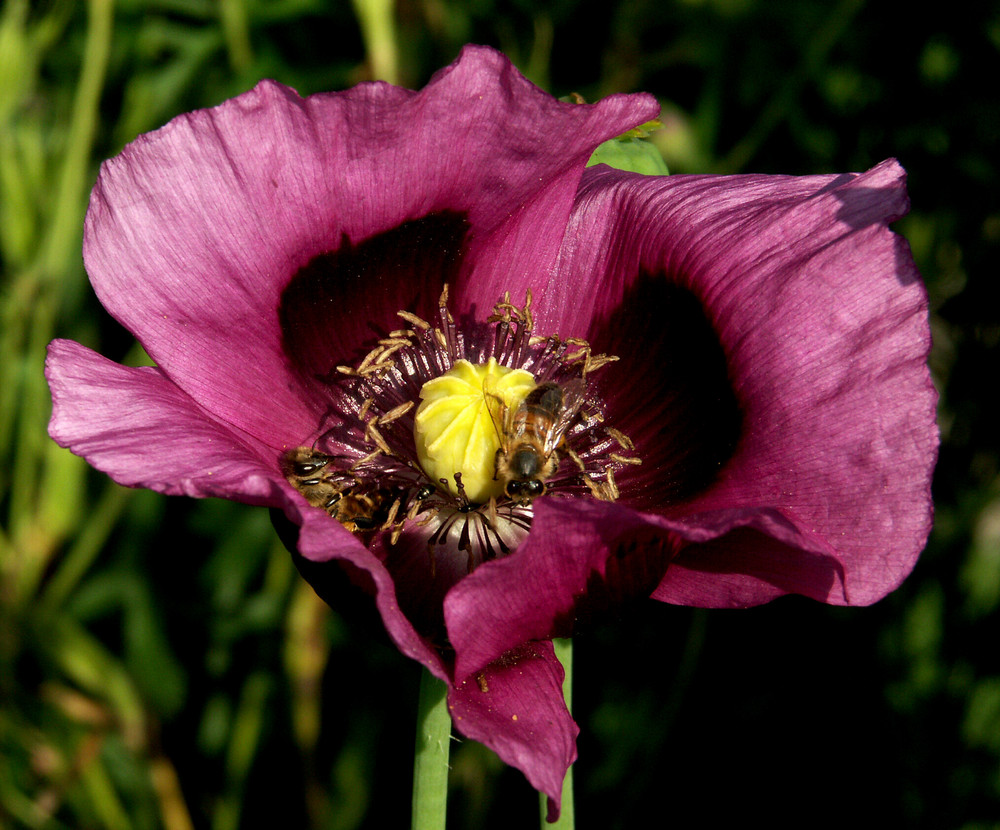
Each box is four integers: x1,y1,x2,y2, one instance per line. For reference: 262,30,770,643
47,47,937,815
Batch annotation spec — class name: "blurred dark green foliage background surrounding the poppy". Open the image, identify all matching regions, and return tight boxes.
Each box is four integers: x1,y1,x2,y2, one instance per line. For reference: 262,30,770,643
0,0,1000,830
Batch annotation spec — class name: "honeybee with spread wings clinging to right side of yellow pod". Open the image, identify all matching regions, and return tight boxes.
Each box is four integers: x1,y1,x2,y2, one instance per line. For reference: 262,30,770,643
487,378,587,506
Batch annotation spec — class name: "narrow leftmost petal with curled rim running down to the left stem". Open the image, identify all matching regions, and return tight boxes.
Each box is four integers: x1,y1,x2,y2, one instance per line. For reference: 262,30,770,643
46,340,448,680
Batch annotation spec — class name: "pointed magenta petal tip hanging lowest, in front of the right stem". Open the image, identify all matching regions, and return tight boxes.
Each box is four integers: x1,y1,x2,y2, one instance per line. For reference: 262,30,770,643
448,642,580,821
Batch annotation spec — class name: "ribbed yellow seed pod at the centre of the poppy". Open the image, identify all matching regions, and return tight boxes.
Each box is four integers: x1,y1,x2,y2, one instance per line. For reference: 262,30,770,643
413,357,535,504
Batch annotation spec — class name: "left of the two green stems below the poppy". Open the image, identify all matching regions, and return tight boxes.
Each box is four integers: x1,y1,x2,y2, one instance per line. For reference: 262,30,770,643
412,669,451,830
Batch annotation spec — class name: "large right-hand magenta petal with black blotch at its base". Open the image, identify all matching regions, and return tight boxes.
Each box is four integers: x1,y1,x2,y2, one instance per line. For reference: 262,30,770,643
560,161,937,605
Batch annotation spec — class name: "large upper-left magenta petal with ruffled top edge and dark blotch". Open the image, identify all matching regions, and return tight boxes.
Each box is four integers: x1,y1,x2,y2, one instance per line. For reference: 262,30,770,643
84,47,656,448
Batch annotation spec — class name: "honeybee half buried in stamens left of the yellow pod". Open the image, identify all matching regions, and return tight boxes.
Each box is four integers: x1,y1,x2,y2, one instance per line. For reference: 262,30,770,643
281,447,393,533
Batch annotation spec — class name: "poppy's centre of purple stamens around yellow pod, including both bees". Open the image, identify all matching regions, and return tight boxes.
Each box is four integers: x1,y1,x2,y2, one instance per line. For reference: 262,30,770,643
280,286,641,570
